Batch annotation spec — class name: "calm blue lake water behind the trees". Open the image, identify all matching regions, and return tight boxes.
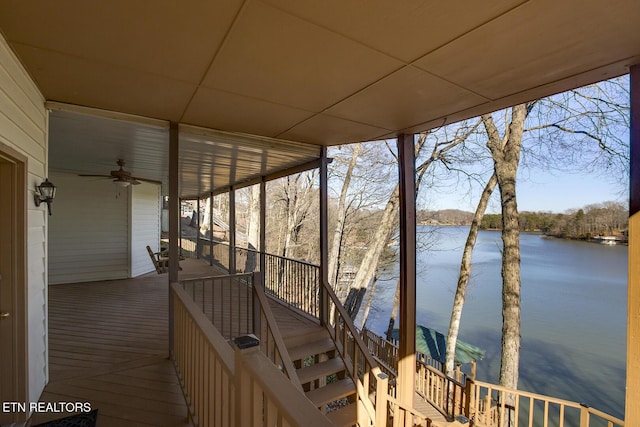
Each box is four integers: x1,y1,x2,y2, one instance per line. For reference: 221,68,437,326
358,227,627,418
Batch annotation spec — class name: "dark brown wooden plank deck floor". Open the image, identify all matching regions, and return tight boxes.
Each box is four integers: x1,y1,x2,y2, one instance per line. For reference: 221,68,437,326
30,259,318,427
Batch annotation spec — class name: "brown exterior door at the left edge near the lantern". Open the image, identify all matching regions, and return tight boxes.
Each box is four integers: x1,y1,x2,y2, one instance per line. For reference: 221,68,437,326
0,149,27,424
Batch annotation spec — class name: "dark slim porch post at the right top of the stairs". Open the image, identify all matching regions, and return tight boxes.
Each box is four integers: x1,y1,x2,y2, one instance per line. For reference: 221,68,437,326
318,146,329,325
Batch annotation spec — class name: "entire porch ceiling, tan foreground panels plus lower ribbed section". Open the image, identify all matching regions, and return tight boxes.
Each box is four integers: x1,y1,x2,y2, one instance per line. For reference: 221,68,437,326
0,0,640,196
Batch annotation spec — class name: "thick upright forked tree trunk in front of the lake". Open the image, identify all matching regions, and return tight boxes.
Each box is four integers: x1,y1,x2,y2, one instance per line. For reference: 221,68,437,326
482,104,533,398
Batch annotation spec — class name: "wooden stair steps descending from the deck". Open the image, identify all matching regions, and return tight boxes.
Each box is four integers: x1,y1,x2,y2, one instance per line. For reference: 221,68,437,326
284,326,356,426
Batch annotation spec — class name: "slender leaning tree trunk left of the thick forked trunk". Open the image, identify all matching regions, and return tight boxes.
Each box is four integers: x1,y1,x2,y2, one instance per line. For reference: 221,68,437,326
445,173,498,376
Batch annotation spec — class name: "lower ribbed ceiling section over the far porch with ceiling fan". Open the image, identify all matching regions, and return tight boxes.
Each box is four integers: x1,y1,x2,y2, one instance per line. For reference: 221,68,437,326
47,107,320,198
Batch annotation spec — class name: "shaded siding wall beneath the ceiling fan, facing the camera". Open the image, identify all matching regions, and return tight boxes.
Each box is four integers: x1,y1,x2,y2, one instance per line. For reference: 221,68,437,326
49,172,130,284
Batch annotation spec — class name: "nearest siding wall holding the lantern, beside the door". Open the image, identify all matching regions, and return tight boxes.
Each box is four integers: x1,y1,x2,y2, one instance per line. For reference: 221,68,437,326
0,35,47,401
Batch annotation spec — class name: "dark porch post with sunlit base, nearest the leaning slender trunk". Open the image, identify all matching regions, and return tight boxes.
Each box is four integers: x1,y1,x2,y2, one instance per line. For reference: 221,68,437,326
397,134,416,407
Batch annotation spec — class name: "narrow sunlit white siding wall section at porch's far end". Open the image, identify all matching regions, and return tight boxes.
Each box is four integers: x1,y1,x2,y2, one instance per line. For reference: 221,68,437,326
131,182,162,277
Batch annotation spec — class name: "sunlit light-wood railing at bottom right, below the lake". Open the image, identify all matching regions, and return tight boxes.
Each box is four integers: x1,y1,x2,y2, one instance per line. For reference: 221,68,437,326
470,381,624,427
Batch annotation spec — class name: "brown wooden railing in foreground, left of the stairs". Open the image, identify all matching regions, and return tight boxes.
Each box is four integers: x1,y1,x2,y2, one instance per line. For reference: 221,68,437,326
170,283,331,427
